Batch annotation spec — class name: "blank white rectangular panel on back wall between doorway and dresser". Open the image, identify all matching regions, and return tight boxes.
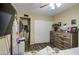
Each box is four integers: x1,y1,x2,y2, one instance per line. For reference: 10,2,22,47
34,20,52,43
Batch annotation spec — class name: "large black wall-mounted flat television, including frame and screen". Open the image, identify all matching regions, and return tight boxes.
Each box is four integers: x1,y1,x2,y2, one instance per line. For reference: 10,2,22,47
0,3,16,36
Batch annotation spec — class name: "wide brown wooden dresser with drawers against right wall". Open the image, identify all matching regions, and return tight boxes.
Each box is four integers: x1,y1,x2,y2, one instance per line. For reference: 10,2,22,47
50,31,78,49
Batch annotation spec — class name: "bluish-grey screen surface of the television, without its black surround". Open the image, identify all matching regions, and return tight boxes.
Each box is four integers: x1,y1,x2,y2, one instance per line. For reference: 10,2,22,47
0,11,12,35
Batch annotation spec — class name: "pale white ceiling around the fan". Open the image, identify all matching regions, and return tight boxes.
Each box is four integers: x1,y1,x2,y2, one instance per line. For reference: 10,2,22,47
13,3,77,16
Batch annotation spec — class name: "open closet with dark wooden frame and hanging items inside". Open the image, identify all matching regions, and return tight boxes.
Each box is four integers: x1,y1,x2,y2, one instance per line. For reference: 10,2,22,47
19,17,30,51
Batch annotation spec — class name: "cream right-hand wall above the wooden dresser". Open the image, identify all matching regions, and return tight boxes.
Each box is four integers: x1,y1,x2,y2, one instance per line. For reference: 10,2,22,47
54,4,79,28
